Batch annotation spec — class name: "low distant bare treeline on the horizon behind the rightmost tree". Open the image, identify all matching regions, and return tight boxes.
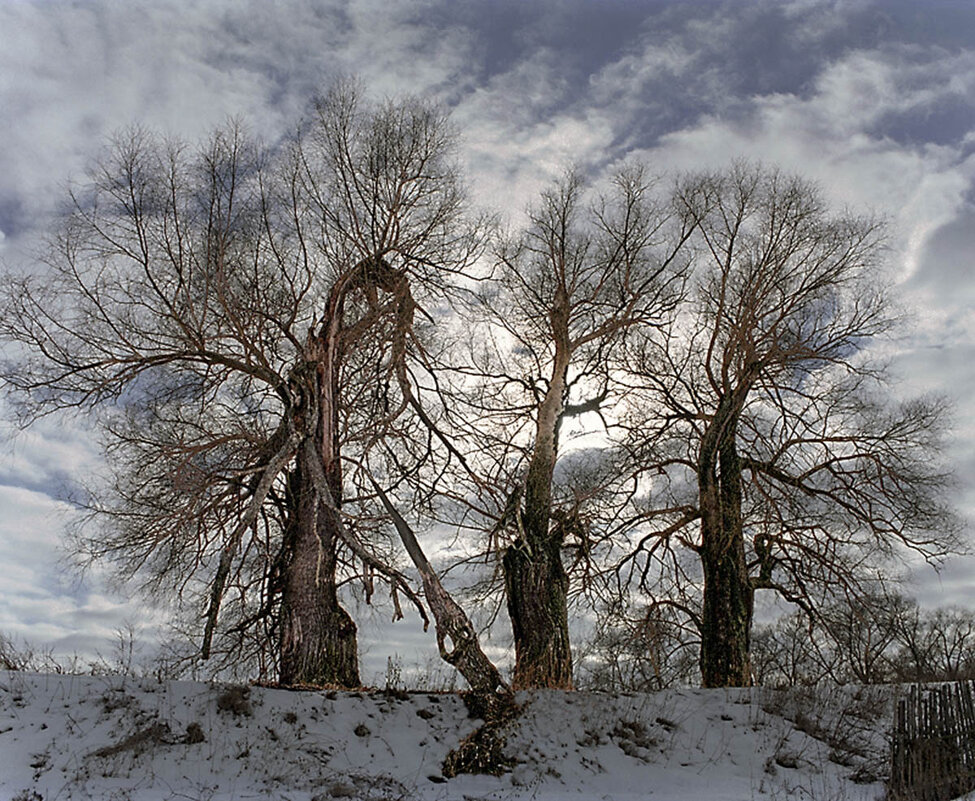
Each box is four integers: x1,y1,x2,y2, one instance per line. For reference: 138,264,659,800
580,592,975,690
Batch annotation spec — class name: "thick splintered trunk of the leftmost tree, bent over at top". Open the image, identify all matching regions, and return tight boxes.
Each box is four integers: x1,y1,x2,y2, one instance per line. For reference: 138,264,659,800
281,257,440,687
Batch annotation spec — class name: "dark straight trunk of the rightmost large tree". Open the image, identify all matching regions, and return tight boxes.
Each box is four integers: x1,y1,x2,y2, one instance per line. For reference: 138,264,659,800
698,404,754,687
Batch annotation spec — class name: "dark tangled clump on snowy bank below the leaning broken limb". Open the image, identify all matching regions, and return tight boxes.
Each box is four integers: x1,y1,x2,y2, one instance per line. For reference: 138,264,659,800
443,691,521,779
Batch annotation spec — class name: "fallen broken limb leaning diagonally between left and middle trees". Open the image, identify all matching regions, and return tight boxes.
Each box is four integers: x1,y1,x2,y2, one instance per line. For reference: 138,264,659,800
369,476,507,692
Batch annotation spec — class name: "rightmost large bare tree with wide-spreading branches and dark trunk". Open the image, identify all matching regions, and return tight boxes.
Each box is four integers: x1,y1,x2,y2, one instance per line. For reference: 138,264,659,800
630,164,957,686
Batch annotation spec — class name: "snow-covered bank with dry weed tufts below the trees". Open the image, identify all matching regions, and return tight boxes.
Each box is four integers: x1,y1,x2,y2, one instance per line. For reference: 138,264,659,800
0,671,891,801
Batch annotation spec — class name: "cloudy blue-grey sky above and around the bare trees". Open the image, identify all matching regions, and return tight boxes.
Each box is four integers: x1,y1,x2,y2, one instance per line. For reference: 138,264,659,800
0,0,975,675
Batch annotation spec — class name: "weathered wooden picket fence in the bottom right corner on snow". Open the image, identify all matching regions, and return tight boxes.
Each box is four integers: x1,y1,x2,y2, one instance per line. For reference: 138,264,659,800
887,681,975,801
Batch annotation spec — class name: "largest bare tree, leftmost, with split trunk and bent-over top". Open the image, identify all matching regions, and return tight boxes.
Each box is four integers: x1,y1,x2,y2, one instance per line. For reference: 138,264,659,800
0,86,488,686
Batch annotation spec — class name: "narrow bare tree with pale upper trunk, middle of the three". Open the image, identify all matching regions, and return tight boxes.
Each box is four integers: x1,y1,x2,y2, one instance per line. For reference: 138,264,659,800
465,169,687,688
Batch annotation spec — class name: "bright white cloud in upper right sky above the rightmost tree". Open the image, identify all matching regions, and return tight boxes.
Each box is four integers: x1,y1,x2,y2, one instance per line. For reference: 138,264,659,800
616,47,975,286
